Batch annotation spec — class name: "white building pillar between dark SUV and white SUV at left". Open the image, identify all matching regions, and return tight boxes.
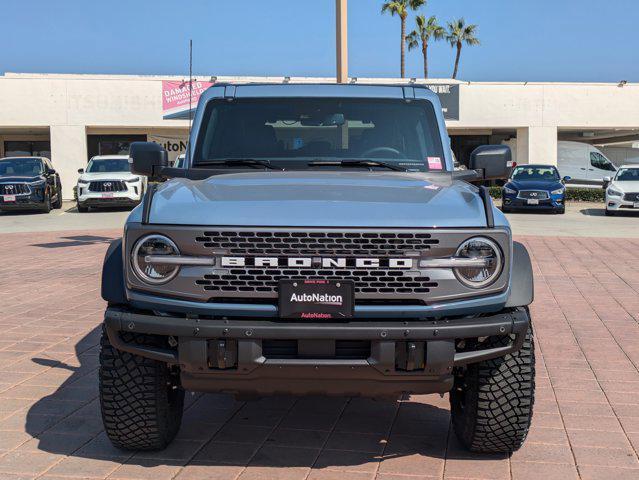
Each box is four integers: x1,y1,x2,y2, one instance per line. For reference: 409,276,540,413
50,125,87,200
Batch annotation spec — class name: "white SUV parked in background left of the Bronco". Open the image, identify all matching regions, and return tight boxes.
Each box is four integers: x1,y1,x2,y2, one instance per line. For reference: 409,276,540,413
77,155,146,212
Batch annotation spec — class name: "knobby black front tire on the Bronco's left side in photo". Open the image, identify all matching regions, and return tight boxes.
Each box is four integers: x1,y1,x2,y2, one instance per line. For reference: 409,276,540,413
99,328,184,450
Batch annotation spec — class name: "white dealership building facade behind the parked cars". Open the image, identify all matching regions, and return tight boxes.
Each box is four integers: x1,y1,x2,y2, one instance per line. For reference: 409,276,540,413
0,73,639,198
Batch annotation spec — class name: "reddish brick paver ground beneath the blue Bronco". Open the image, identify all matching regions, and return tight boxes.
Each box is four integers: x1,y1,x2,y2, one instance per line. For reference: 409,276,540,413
0,231,639,480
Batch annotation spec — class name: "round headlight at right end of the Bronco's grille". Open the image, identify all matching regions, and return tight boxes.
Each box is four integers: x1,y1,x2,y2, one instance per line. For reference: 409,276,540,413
454,237,503,288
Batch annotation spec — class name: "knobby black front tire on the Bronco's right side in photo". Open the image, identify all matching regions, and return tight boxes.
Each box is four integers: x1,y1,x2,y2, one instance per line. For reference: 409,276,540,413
450,316,535,453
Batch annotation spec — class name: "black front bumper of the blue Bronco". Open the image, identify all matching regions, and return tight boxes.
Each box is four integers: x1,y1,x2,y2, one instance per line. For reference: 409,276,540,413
105,307,530,396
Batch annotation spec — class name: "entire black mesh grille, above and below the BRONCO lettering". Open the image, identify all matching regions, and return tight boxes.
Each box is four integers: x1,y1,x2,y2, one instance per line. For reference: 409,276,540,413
195,230,439,295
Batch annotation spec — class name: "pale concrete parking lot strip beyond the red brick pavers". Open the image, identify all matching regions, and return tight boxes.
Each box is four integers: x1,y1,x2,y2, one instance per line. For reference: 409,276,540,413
0,201,639,238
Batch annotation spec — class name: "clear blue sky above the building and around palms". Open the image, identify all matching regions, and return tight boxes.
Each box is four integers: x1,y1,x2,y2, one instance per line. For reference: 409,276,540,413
0,0,639,82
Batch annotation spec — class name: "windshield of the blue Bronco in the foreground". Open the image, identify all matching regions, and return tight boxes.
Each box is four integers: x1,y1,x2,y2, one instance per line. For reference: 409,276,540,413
193,98,446,171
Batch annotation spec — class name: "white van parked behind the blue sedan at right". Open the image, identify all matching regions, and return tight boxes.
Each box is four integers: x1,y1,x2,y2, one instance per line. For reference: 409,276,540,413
502,139,617,187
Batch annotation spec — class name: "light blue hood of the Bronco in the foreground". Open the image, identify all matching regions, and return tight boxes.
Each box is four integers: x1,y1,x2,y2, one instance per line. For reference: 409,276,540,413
149,171,486,227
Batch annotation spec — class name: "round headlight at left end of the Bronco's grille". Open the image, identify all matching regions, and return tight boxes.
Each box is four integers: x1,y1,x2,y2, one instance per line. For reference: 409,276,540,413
131,235,180,285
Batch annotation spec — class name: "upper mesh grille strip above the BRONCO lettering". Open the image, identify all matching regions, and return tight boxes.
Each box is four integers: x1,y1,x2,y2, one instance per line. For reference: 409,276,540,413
195,230,439,257
